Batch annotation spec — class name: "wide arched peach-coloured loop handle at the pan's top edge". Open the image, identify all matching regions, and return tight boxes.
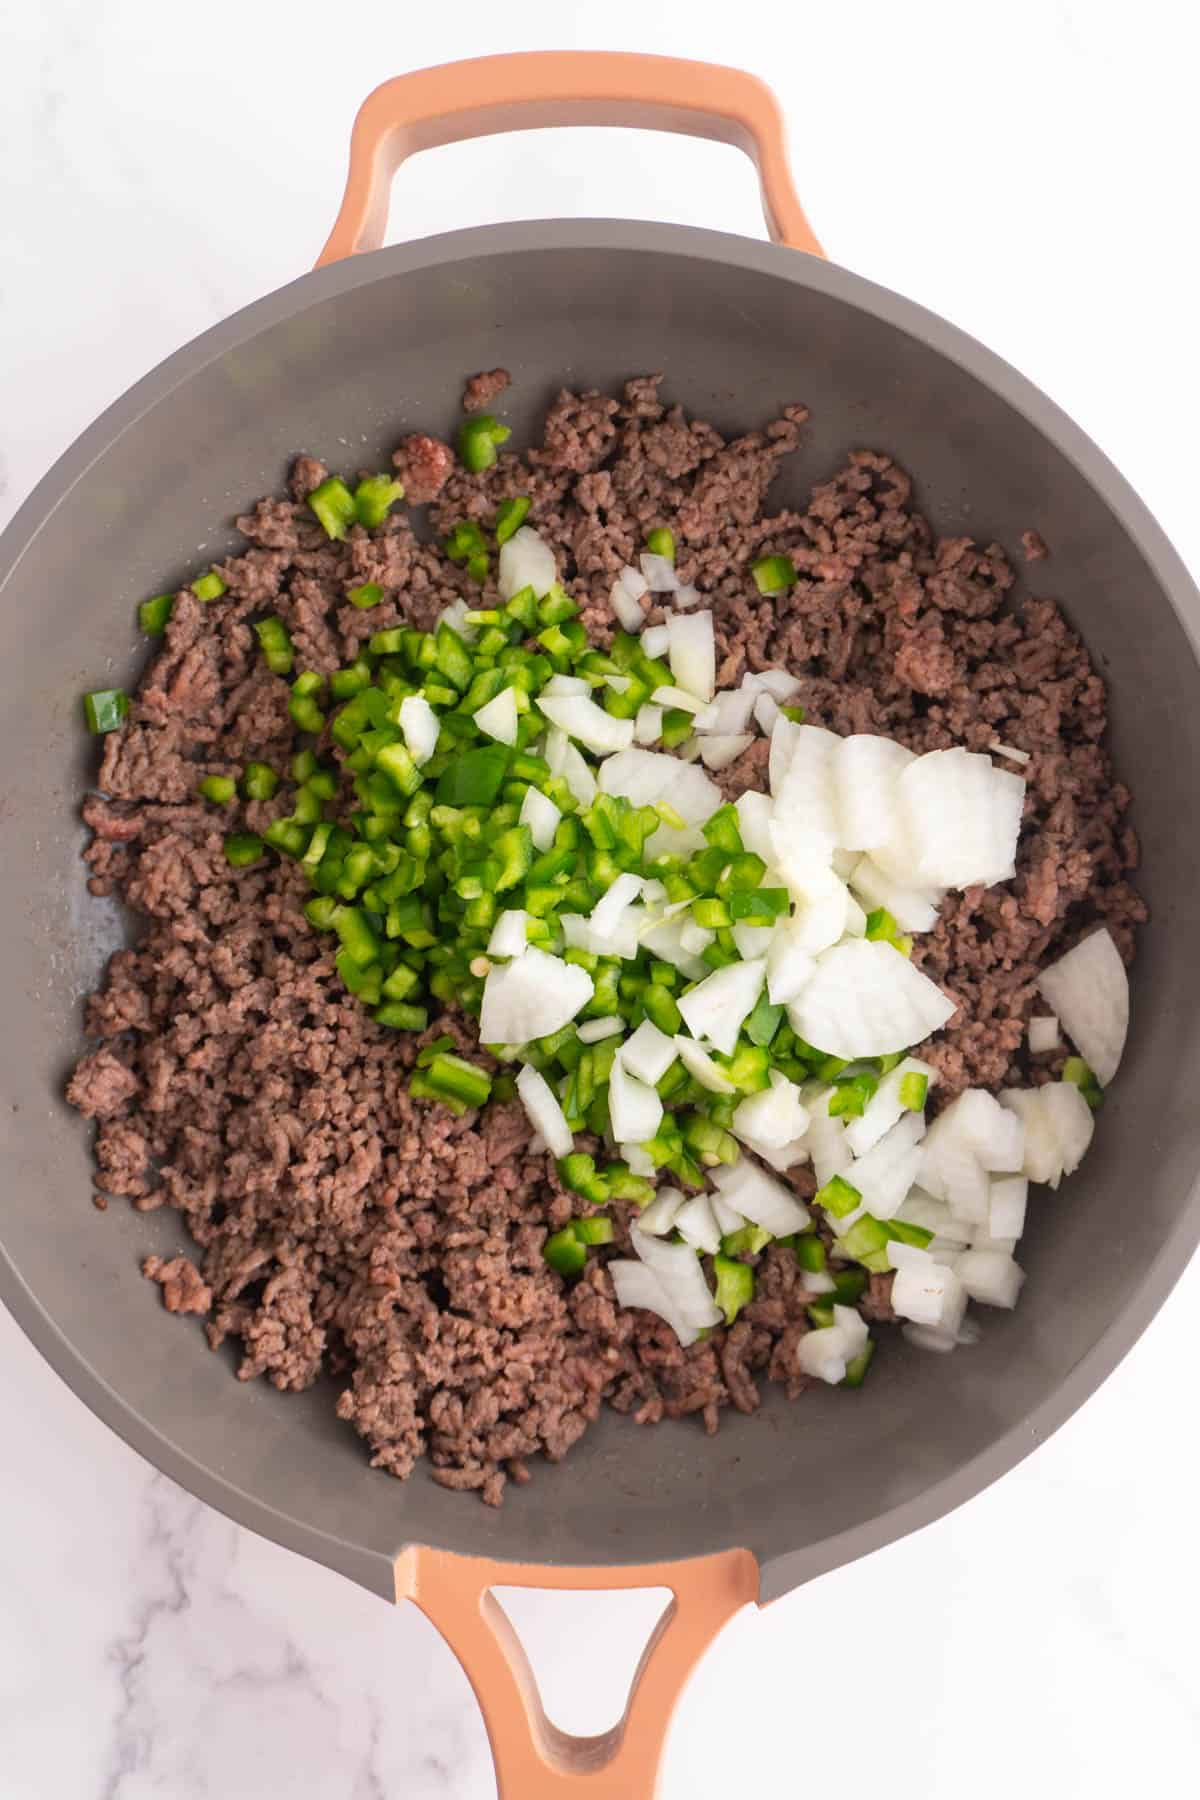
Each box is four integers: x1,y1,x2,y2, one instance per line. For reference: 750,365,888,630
317,50,824,268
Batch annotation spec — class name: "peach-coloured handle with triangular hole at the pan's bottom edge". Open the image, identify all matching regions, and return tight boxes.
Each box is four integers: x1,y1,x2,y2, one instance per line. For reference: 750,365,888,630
396,1544,759,1800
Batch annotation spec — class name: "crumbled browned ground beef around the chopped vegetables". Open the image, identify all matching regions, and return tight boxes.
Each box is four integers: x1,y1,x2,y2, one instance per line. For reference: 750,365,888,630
68,383,1144,1505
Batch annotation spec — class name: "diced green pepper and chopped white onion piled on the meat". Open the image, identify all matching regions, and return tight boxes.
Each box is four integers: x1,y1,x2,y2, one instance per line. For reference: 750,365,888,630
85,471,1128,1386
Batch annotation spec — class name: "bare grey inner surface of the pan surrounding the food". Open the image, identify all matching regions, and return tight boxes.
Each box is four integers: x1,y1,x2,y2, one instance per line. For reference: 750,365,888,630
0,221,1200,1598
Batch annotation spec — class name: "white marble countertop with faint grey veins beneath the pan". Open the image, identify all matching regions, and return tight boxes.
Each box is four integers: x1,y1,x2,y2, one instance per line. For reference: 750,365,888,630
0,0,1200,1800
